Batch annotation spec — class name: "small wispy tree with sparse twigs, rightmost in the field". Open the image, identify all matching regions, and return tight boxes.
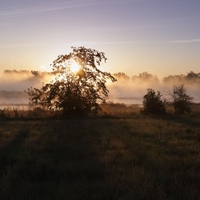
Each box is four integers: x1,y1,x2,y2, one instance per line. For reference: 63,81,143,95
168,85,193,115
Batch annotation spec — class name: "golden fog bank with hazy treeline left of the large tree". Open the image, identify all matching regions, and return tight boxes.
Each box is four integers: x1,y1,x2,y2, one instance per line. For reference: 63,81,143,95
0,70,50,104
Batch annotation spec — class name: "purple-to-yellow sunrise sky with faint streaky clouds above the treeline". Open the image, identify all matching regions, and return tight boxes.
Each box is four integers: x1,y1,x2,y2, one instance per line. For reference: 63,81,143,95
0,0,200,78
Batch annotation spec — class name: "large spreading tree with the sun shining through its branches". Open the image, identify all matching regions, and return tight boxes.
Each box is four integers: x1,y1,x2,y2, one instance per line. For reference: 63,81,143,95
26,47,116,115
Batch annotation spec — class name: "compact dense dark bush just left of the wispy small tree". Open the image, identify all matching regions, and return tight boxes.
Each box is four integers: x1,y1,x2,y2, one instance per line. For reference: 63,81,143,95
141,89,166,115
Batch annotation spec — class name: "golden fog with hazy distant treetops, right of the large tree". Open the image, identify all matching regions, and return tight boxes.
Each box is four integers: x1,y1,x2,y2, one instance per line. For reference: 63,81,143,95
108,72,200,104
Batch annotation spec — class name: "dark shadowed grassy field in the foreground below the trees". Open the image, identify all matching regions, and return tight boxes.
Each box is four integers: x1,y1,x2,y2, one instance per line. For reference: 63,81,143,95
0,105,200,200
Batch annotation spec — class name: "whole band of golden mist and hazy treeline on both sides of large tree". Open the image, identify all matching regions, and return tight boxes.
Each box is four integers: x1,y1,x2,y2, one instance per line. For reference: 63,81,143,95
0,70,200,104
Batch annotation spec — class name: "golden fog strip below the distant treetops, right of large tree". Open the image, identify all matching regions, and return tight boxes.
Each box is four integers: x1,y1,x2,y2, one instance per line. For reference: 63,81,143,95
108,82,200,104
